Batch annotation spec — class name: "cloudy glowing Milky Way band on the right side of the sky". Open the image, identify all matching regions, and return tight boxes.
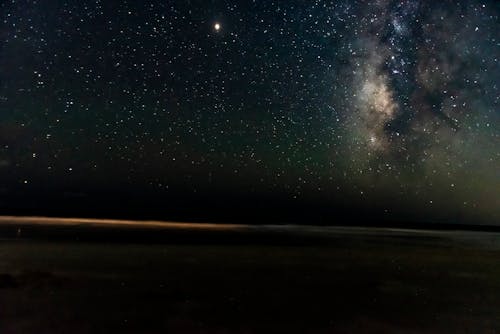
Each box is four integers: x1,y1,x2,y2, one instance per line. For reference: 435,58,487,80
347,1,500,224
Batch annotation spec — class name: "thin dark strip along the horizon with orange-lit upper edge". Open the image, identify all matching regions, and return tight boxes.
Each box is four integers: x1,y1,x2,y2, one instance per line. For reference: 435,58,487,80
0,216,500,244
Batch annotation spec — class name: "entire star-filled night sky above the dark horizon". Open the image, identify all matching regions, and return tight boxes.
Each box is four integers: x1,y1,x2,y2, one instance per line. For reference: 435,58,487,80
0,0,500,224
